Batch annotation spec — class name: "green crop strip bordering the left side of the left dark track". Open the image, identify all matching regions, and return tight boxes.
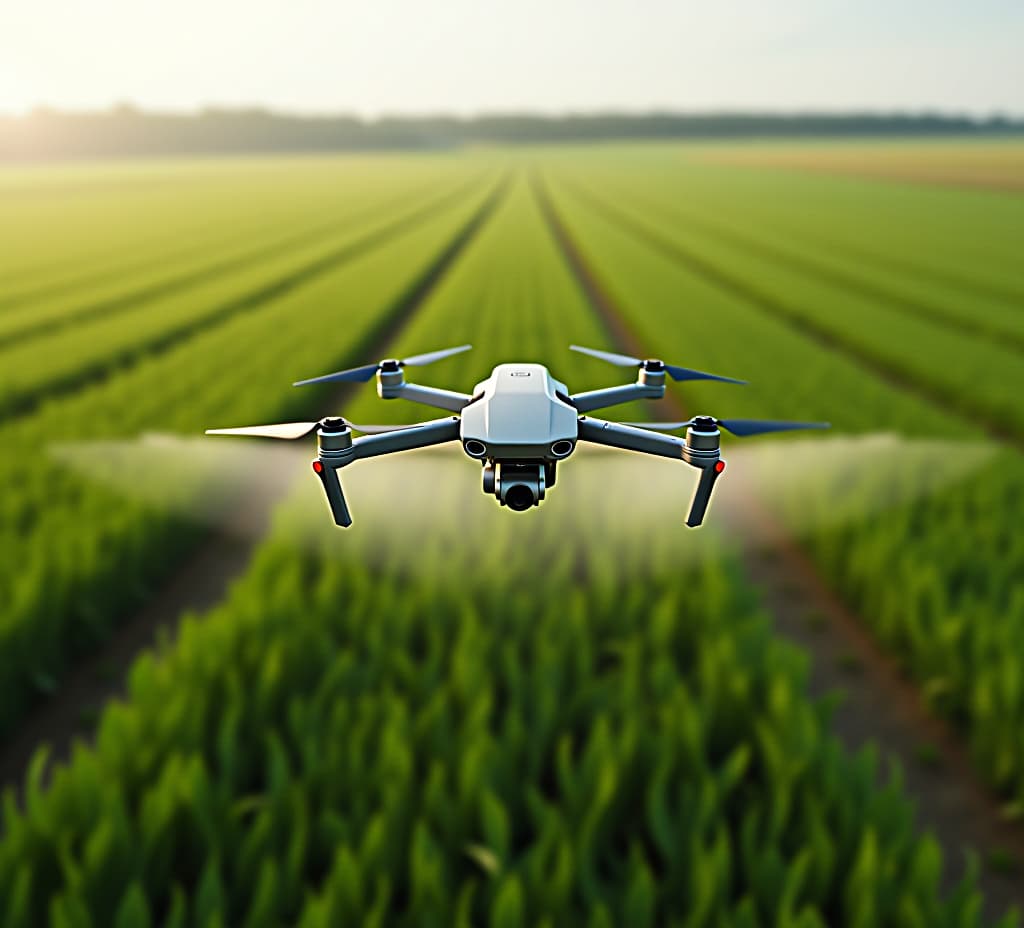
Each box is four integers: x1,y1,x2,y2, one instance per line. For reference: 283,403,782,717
0,170,495,727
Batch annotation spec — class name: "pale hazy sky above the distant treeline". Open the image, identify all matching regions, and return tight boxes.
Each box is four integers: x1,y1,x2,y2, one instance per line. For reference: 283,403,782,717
0,0,1024,116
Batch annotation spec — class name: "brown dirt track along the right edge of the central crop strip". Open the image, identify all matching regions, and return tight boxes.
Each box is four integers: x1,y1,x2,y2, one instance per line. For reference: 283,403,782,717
534,175,1024,919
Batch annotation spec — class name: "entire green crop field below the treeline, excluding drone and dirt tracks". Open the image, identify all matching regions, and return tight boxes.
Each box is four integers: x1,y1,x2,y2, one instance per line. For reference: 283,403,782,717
0,142,1024,928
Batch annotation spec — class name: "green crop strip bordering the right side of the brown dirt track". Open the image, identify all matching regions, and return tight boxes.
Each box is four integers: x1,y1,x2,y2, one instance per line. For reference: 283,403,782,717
536,164,1024,808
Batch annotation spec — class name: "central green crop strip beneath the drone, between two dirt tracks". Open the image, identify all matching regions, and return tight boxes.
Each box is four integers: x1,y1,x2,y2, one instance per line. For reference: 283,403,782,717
0,172,999,928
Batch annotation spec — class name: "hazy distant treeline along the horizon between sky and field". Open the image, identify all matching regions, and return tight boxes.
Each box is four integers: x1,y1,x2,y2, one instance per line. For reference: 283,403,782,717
0,107,1024,161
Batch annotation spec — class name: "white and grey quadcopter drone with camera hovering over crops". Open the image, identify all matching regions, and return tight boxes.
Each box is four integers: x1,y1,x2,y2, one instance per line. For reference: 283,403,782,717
207,345,828,529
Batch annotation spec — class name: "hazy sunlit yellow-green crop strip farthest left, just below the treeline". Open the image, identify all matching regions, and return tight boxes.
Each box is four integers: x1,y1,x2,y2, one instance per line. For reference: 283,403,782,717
0,158,450,303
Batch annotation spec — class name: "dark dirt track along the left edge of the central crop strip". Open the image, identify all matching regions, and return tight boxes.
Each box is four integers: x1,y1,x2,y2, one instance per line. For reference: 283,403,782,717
0,176,510,792
